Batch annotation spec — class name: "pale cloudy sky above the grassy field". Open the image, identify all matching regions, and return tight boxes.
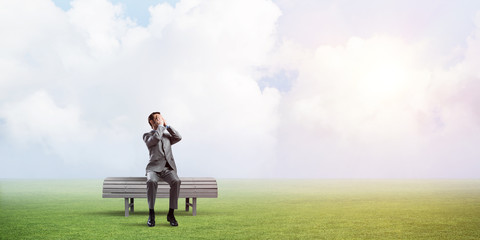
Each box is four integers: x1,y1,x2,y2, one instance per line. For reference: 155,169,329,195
0,0,480,178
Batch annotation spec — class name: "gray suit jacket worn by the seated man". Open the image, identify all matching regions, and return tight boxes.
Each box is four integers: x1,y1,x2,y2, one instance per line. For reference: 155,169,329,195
143,126,182,172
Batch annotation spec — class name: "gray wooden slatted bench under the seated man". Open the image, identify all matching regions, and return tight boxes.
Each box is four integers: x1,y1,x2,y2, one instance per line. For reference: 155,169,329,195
102,177,218,217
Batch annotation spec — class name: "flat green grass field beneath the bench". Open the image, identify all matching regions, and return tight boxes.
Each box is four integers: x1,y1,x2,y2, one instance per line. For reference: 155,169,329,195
0,179,480,239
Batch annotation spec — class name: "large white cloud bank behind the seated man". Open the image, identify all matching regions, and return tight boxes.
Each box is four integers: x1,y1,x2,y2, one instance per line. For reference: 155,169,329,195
0,0,280,177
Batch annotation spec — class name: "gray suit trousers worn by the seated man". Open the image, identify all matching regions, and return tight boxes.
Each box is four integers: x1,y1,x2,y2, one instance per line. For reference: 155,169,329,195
147,167,181,209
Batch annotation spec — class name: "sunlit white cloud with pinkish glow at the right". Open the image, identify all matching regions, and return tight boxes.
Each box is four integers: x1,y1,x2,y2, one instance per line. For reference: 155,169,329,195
274,30,480,178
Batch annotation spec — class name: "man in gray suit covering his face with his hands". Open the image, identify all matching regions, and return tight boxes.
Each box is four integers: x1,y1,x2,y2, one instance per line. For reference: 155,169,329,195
143,112,182,227
